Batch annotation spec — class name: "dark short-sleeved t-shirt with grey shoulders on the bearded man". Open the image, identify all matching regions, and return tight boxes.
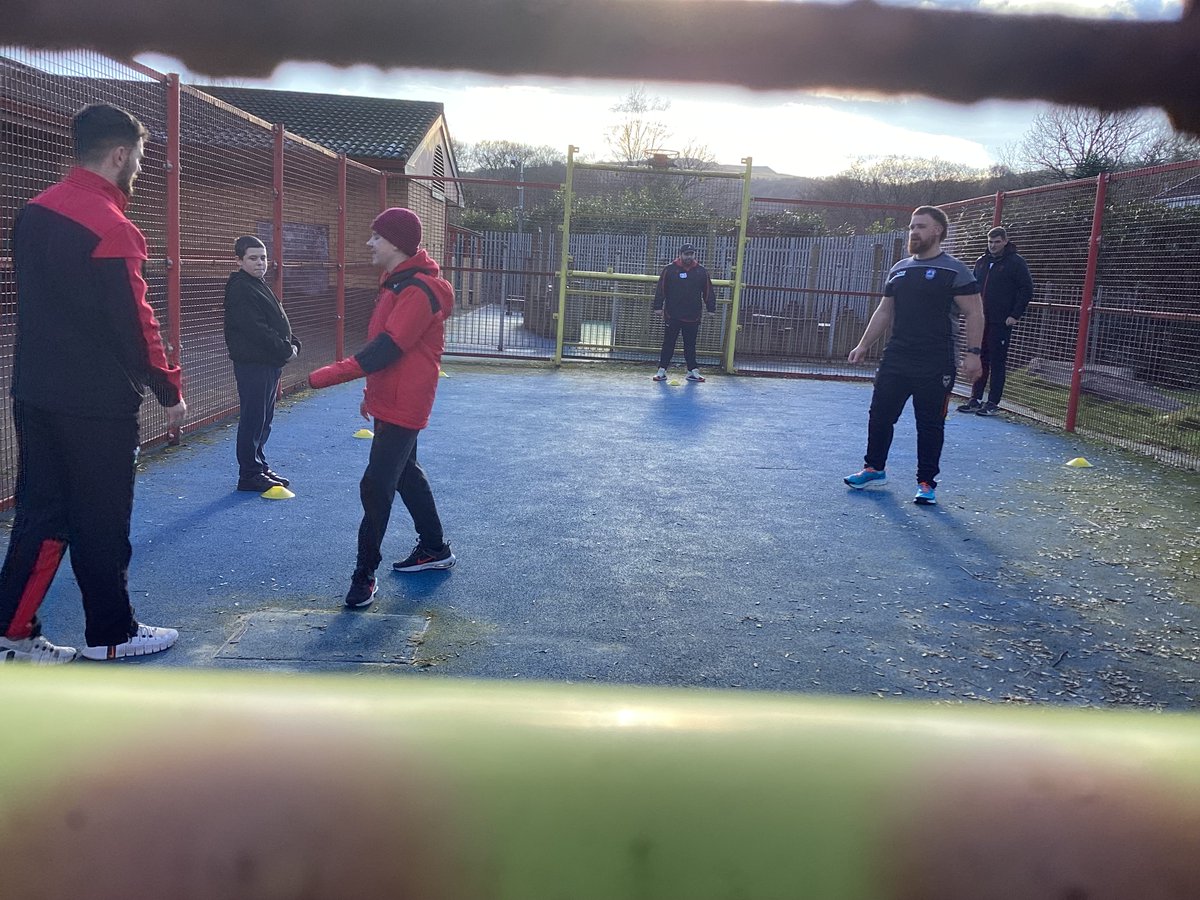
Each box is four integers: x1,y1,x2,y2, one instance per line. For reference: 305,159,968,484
880,253,979,376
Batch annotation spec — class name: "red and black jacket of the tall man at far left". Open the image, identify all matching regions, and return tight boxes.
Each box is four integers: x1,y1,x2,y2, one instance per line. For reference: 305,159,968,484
12,168,182,419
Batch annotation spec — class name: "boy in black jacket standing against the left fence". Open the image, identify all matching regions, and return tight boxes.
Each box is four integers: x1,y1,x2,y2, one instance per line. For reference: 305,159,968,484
224,234,300,493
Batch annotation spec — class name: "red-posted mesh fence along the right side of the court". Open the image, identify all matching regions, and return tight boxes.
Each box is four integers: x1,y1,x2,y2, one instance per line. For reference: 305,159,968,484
943,170,1200,468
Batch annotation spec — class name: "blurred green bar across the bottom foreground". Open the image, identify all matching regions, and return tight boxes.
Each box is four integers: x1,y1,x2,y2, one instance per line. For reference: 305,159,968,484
0,664,1200,900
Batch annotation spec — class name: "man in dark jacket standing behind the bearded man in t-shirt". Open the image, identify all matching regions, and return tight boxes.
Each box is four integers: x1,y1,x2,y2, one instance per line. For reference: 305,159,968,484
959,226,1033,415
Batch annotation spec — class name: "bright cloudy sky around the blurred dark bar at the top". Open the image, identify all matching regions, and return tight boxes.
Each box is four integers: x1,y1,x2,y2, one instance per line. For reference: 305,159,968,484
138,0,1182,178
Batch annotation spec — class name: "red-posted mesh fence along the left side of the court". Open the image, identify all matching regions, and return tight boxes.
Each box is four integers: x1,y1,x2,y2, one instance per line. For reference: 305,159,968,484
0,48,415,503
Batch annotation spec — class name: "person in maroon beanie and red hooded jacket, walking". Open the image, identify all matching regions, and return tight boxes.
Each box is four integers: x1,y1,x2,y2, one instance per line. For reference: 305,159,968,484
308,206,455,607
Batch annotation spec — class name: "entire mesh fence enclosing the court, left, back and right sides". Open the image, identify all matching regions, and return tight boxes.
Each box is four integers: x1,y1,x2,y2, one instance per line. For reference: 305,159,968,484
0,48,1200,508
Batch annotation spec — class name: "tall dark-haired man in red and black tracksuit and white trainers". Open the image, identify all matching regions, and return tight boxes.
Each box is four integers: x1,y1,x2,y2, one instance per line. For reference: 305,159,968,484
0,103,187,664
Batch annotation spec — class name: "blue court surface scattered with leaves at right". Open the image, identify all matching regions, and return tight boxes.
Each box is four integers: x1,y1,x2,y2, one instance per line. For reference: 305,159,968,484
9,359,1200,709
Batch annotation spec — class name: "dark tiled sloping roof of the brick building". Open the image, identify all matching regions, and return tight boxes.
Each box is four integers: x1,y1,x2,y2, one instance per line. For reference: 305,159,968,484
196,84,444,160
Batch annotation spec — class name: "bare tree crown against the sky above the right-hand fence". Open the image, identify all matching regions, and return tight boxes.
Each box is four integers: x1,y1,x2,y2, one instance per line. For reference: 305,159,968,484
1016,107,1158,180
